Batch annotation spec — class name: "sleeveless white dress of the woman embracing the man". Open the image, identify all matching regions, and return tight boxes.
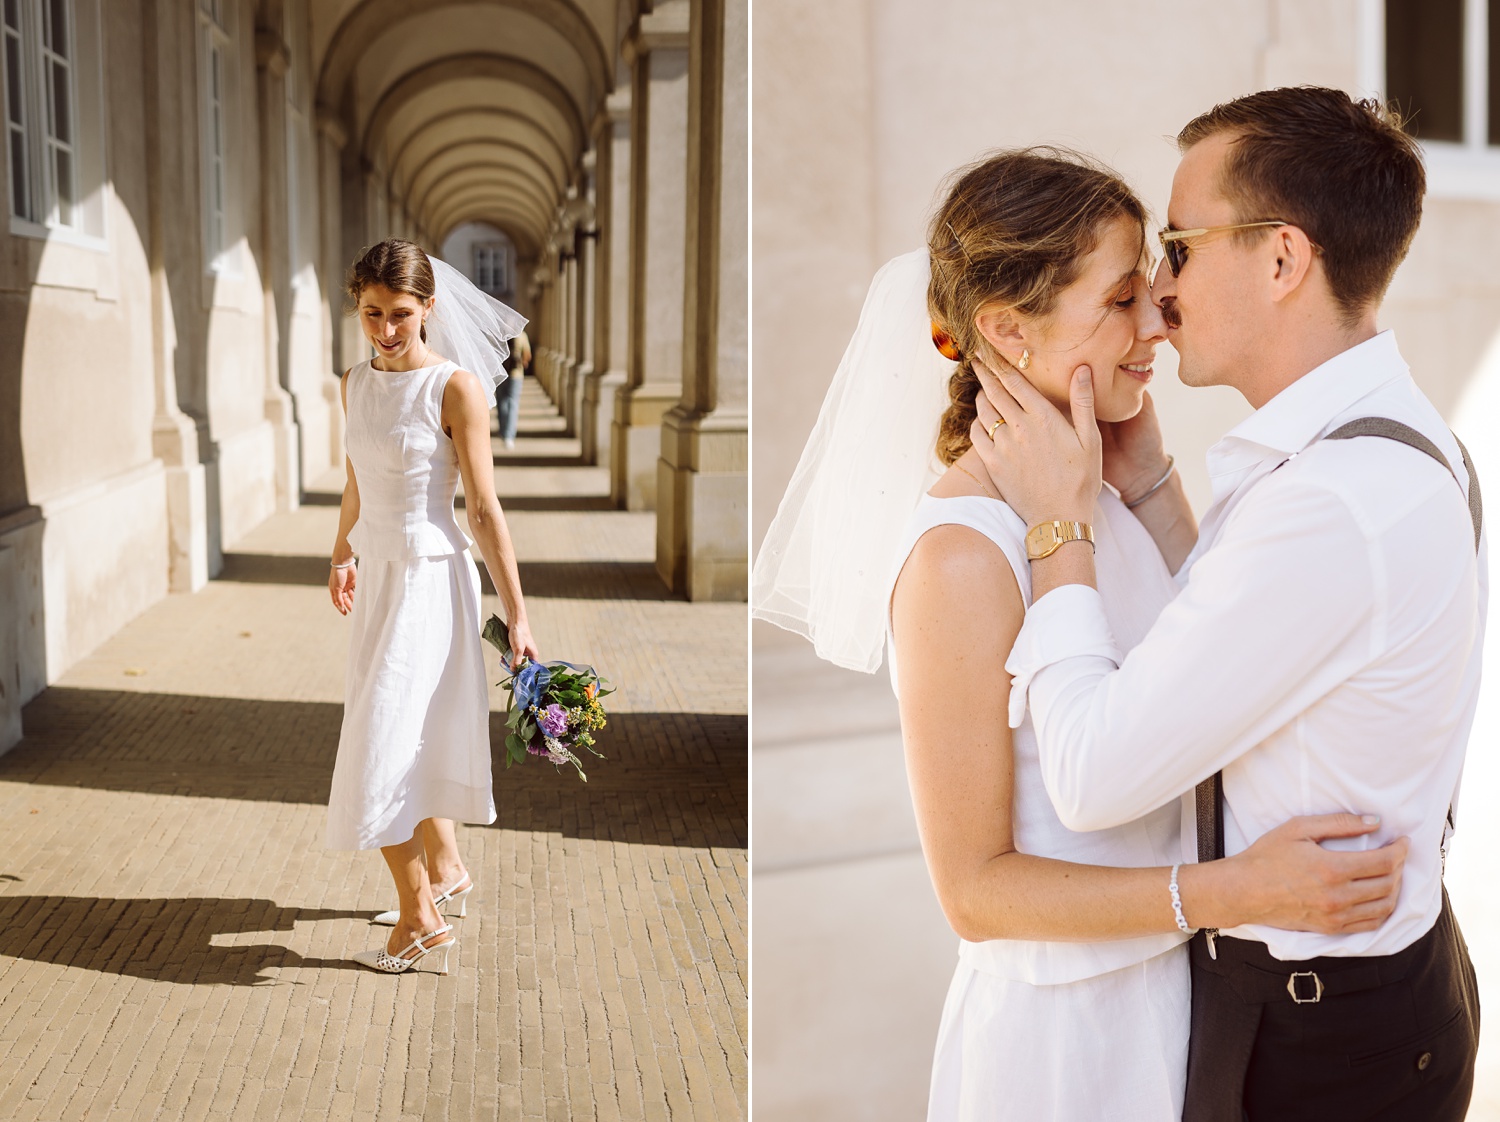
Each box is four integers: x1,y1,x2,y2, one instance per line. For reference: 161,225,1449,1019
888,491,1196,1122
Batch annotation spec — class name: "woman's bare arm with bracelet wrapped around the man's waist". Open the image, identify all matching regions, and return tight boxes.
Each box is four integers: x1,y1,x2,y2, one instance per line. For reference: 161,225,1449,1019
891,525,1406,942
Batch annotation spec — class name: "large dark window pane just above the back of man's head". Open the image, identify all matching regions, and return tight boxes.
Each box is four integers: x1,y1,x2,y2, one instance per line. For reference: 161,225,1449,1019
1386,0,1464,141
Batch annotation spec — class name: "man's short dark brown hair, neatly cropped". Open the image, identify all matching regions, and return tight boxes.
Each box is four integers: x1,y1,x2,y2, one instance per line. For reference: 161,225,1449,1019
1178,86,1427,323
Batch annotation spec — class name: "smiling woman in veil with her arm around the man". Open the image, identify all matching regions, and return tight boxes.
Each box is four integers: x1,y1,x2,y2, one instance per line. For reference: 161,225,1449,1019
752,149,1406,1121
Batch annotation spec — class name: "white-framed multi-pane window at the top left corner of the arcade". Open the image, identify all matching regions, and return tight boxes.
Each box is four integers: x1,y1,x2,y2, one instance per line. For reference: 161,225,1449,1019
3,0,83,228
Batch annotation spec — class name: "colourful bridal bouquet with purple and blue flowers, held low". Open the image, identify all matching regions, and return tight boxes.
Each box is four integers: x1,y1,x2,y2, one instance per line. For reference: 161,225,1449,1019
480,615,614,783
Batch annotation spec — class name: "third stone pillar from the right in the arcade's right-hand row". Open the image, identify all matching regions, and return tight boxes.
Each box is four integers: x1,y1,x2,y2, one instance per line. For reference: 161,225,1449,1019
579,86,630,465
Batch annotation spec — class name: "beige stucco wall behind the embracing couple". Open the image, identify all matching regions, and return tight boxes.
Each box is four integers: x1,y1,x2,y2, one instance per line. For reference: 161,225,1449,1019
752,0,1500,1119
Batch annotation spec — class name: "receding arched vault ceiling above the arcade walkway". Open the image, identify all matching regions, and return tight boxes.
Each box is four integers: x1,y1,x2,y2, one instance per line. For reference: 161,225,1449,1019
308,0,633,257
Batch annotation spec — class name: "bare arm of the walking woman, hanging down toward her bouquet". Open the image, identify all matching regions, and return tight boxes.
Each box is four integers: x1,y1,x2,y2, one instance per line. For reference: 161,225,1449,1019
443,371,542,659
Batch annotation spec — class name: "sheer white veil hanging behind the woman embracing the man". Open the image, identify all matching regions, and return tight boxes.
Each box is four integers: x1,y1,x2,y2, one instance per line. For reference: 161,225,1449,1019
750,249,953,674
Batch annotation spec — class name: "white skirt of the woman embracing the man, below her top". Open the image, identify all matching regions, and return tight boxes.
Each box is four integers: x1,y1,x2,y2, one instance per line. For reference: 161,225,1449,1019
927,945,1193,1122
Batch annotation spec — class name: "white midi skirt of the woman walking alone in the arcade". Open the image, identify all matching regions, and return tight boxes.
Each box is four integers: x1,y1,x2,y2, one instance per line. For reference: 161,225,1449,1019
327,554,495,849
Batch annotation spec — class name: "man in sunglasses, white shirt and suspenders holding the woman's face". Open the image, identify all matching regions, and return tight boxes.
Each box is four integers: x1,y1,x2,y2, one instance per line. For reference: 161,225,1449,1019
974,89,1487,1122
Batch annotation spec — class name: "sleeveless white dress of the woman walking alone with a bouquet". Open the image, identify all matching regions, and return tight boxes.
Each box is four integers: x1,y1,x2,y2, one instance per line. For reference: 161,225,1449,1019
327,362,495,849
